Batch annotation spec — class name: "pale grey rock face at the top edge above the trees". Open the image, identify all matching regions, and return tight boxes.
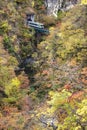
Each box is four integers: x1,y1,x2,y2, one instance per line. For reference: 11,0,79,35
45,0,80,17
